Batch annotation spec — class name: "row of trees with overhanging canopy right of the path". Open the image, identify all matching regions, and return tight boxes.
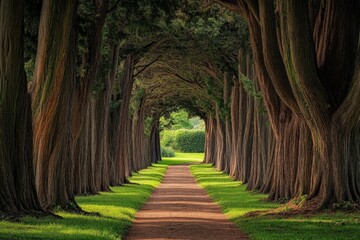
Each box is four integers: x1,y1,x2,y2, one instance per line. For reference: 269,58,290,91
136,0,360,209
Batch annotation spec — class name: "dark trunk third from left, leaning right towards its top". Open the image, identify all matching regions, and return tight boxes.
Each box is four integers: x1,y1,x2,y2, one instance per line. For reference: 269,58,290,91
71,0,109,194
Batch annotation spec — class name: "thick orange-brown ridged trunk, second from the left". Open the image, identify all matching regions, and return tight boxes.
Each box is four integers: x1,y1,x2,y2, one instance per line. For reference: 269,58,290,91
32,0,77,208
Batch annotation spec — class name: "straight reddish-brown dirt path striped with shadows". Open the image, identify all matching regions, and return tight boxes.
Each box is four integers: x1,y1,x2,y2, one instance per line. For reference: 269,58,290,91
125,165,248,240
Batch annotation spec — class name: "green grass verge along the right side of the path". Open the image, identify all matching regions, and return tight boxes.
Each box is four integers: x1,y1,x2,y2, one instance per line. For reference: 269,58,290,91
190,164,360,240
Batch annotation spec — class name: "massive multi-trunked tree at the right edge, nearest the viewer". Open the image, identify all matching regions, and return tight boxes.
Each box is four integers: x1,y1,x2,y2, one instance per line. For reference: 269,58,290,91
217,0,360,207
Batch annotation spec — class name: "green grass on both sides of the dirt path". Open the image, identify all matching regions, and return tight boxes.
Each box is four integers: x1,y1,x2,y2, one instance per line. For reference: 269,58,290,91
0,153,360,240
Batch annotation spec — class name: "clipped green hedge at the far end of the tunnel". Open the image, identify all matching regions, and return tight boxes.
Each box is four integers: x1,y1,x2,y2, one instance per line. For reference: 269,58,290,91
175,129,205,152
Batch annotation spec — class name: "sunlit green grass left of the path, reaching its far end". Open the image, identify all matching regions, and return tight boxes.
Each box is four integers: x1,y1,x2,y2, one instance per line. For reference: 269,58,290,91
0,153,202,240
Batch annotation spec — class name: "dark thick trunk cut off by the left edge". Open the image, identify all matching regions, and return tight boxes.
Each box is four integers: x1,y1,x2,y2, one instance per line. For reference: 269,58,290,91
0,0,43,218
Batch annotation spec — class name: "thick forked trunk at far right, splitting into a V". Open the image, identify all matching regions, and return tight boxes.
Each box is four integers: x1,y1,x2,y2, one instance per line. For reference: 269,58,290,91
280,1,360,206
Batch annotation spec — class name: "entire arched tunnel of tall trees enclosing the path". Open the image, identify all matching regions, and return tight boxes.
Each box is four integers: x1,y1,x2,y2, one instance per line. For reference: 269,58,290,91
0,0,360,218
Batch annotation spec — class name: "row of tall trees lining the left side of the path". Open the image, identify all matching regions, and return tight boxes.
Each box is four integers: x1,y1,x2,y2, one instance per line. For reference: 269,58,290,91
0,0,172,216
